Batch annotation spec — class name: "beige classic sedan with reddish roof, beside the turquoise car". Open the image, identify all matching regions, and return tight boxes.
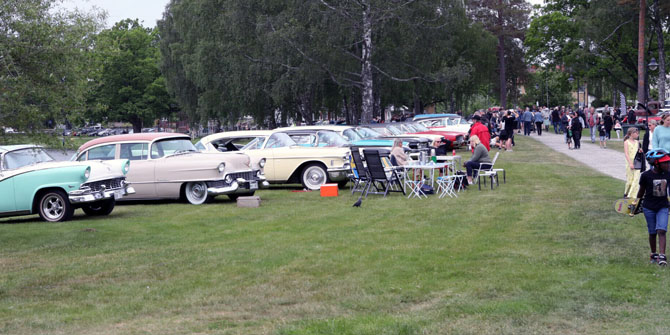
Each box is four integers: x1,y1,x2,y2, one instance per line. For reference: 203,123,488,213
73,133,269,205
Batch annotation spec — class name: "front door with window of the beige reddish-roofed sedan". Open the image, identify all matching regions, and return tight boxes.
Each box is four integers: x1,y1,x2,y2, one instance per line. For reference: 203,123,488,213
119,142,156,199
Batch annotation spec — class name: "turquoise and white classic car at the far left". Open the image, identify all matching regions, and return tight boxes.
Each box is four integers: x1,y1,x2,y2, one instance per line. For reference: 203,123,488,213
0,145,135,222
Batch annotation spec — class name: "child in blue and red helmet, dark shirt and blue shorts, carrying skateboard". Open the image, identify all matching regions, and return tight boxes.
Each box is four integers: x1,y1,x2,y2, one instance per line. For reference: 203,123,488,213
630,149,670,266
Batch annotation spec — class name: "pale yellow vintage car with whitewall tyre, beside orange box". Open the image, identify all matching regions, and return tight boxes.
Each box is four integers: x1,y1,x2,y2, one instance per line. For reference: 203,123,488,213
195,130,350,190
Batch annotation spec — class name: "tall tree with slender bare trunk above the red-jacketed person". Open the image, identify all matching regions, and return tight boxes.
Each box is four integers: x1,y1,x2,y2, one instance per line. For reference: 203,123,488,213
467,0,530,106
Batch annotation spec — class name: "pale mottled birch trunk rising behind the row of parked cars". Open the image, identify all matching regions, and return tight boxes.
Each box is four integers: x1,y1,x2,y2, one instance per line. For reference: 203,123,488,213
361,0,374,124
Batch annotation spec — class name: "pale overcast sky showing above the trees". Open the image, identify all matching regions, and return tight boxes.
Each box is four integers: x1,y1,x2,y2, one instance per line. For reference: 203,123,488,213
57,0,544,28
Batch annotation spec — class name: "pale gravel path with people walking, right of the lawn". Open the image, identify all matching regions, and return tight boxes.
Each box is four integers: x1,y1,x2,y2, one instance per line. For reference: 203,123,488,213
528,131,626,181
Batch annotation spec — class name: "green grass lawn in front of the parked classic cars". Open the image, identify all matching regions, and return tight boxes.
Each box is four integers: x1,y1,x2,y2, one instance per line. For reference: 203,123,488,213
0,136,670,335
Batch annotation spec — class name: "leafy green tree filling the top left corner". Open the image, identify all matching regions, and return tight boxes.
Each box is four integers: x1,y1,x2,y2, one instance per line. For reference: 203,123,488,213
0,0,103,131
